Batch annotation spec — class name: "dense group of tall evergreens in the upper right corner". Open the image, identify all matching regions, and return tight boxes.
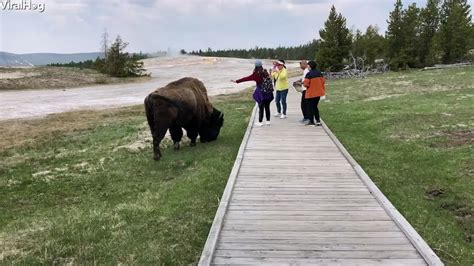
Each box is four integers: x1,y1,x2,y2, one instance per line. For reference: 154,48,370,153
385,0,474,69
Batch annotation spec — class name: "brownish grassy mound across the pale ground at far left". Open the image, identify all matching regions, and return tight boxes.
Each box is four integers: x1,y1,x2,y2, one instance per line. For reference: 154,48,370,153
0,67,150,91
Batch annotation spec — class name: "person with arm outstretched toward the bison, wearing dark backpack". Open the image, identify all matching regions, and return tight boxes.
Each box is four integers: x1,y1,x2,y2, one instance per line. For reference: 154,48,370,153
231,60,274,127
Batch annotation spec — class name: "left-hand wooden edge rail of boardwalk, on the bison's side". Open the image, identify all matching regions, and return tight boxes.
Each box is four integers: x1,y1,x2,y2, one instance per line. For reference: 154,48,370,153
198,106,257,266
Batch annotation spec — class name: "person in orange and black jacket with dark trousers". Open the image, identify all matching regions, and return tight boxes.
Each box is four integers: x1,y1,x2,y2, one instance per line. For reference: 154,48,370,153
304,61,326,126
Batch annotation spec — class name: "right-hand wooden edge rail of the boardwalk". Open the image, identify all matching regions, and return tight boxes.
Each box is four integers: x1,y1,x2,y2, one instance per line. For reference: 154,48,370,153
322,122,444,265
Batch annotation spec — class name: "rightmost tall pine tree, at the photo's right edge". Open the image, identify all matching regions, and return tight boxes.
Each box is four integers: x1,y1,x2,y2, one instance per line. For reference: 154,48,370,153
437,0,473,64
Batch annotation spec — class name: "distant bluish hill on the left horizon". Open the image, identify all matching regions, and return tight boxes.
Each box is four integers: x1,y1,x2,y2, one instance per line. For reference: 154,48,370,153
0,52,103,66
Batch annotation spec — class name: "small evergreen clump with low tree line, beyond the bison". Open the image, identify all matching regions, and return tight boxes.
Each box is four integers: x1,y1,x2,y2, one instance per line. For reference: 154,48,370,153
48,36,147,77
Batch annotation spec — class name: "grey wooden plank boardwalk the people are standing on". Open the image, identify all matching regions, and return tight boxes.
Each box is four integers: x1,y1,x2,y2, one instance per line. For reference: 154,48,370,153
199,88,442,265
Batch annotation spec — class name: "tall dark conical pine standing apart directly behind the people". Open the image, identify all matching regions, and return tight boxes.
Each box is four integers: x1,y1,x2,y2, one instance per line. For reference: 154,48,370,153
316,6,352,71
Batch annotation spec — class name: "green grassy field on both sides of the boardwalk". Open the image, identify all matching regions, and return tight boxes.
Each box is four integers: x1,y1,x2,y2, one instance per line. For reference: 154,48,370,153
0,68,474,265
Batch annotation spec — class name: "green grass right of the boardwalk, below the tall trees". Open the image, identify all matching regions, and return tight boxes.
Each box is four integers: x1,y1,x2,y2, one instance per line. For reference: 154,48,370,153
321,68,474,265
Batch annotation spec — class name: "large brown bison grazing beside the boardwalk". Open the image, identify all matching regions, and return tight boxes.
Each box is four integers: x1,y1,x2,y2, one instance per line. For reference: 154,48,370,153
145,77,224,160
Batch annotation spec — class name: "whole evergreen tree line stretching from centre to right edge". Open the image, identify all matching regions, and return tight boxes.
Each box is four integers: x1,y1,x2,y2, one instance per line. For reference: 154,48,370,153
187,0,474,71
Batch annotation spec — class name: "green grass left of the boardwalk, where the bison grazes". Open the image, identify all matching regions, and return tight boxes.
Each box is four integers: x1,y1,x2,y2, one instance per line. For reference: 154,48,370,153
0,92,253,265
